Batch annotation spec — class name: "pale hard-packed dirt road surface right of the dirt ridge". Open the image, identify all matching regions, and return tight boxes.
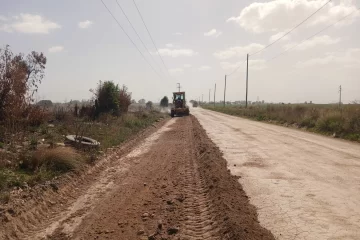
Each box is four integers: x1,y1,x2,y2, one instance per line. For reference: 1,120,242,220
192,108,360,239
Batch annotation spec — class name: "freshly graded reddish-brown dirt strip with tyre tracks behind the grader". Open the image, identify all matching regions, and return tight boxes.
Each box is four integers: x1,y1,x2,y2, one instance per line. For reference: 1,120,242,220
0,117,274,240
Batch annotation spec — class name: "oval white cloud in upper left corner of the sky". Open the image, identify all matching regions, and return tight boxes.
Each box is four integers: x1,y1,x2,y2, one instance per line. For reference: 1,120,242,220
9,13,61,34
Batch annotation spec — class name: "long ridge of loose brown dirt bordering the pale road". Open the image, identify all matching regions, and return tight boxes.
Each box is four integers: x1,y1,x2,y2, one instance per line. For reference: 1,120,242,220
191,116,274,239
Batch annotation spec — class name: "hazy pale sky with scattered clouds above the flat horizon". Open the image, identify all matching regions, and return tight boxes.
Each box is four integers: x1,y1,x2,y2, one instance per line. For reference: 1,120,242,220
0,0,360,103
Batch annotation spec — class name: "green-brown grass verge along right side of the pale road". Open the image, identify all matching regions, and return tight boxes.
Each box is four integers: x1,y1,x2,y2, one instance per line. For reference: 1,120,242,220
203,104,360,142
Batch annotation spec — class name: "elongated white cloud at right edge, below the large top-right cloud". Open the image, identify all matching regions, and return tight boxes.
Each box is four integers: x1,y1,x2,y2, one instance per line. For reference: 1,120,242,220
296,48,360,68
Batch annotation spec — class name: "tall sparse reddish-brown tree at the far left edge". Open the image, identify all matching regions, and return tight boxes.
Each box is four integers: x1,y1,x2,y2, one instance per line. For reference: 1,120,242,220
0,45,46,124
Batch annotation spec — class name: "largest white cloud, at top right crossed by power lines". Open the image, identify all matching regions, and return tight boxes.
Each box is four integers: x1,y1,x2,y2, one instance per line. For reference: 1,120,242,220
227,0,360,33
